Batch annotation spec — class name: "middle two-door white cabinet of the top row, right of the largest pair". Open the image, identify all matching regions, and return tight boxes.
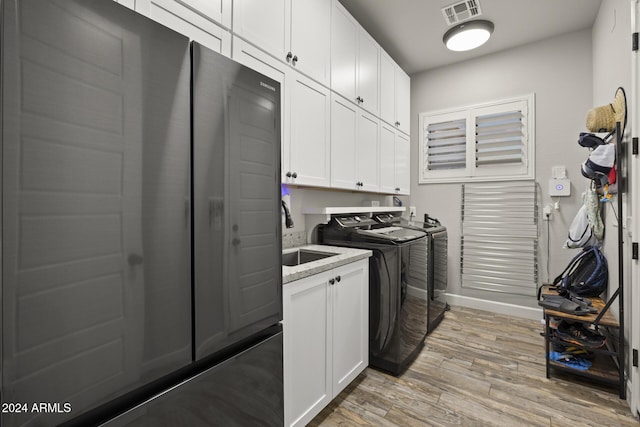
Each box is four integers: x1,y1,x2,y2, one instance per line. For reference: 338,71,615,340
331,0,381,115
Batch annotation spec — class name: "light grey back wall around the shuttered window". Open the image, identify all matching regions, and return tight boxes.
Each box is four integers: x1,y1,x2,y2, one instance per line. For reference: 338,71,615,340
410,30,593,314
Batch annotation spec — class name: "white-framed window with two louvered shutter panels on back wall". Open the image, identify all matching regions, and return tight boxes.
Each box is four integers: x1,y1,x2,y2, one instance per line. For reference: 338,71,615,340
419,94,535,184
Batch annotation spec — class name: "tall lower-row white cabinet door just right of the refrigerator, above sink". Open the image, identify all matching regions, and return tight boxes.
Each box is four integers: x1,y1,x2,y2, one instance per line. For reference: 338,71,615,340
290,71,331,187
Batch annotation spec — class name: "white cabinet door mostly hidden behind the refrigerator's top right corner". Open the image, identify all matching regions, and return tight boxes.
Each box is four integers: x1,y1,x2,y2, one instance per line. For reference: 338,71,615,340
233,36,290,182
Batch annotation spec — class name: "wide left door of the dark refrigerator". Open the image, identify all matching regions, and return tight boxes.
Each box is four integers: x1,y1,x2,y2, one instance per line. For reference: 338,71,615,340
2,0,191,425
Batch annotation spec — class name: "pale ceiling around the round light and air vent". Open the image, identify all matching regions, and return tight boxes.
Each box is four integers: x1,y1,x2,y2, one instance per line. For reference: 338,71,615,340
340,0,601,74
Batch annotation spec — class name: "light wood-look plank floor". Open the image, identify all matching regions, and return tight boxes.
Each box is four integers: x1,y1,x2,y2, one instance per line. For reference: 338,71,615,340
309,307,640,427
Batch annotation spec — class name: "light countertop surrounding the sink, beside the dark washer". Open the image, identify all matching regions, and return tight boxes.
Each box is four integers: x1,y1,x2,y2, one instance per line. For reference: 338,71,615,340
282,245,373,285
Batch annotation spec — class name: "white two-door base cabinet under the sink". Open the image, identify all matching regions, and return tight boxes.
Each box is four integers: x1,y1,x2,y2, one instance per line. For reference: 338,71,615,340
283,259,369,426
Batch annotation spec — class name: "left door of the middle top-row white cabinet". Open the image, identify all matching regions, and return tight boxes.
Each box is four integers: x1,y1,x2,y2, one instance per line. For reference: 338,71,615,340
331,0,360,102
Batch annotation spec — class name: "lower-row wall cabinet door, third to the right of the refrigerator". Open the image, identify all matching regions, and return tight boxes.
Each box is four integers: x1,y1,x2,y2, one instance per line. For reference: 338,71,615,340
356,110,380,191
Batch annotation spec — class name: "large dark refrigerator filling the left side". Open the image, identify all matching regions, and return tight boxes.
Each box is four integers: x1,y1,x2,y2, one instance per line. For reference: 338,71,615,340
0,0,283,427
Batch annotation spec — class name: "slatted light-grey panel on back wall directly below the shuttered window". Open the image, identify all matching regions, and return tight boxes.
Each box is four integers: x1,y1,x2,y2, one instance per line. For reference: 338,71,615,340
460,181,538,296
